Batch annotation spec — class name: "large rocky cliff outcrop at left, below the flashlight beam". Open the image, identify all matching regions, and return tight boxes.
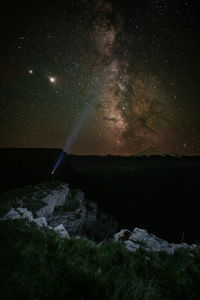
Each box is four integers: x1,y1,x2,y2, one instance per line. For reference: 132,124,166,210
2,183,118,241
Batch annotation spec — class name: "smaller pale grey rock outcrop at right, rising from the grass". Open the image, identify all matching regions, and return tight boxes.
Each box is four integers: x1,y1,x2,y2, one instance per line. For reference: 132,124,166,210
114,227,196,254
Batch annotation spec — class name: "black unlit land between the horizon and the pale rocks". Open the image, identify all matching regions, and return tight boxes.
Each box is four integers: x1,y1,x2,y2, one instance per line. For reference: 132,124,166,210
0,149,200,243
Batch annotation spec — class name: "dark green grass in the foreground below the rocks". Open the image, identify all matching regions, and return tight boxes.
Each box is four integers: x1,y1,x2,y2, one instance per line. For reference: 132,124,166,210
0,220,200,300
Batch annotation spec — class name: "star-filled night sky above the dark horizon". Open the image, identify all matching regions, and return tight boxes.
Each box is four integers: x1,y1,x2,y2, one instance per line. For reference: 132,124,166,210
0,0,200,155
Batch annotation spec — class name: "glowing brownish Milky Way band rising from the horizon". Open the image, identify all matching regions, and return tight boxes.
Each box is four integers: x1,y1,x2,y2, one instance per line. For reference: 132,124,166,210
87,1,195,155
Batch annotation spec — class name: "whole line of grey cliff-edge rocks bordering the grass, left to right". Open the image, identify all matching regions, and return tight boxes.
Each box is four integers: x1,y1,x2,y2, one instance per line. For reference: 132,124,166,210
0,183,196,255
